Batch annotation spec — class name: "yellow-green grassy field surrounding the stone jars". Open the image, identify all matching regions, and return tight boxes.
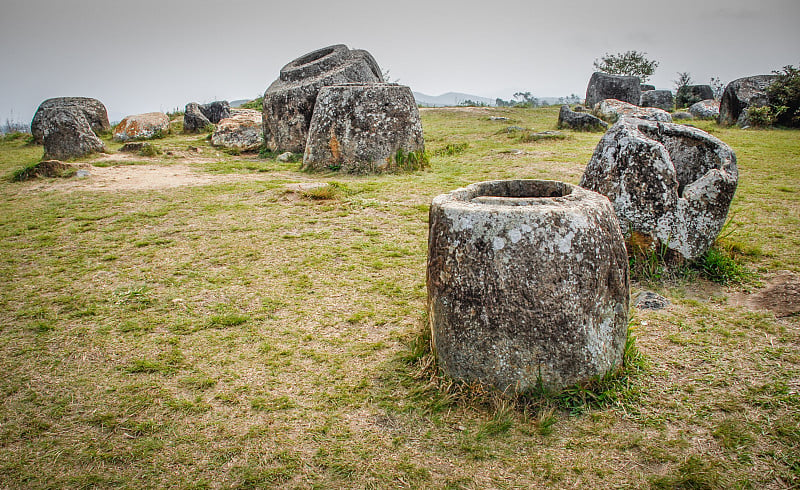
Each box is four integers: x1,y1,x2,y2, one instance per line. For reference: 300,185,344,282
0,108,800,488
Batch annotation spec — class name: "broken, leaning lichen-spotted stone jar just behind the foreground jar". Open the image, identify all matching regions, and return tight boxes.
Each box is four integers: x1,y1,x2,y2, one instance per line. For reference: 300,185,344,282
580,118,738,260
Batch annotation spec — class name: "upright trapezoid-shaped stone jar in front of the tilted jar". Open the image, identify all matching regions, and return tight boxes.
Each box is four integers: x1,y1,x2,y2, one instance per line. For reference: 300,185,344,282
303,83,425,173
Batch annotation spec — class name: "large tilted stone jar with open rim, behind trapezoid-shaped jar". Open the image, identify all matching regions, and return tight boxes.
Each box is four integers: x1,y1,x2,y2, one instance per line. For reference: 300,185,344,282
263,44,382,153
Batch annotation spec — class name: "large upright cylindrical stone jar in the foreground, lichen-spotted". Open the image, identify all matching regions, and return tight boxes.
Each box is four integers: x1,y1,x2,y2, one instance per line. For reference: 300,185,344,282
427,180,629,392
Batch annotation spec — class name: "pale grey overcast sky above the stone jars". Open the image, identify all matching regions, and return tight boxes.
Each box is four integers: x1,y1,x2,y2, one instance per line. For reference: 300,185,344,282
0,0,800,122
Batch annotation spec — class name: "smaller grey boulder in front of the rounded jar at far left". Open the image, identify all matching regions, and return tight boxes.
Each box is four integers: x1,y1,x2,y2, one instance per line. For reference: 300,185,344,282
40,108,105,160
